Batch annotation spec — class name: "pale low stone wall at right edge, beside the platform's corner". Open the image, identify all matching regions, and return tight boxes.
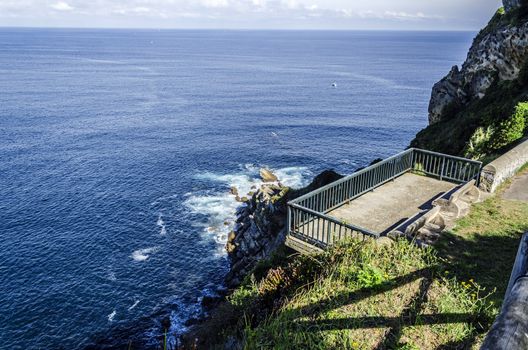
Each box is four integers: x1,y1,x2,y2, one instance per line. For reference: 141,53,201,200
479,139,528,193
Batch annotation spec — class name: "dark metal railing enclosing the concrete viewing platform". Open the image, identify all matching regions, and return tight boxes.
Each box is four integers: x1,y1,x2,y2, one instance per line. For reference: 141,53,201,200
288,148,482,248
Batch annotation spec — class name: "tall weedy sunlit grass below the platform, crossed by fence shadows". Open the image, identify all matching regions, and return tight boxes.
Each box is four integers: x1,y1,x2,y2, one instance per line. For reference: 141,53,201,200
244,240,493,349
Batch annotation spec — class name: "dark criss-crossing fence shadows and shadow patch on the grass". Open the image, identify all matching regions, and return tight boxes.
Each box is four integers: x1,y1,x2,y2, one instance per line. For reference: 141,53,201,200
276,249,500,350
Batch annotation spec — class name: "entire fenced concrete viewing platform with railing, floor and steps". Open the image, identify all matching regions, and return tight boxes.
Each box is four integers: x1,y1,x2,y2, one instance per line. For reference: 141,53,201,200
286,148,482,252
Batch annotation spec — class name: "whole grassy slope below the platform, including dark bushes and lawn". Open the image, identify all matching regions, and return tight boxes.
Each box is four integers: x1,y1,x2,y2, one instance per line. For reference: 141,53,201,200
207,167,528,349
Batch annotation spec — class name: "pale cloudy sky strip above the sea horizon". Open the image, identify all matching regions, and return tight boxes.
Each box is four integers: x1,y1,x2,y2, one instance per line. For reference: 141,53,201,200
0,0,501,30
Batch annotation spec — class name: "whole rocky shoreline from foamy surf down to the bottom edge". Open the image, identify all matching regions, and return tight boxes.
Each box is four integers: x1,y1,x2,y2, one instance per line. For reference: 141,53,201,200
180,169,343,349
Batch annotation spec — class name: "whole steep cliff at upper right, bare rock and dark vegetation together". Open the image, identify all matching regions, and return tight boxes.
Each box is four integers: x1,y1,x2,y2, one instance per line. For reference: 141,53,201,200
412,0,528,153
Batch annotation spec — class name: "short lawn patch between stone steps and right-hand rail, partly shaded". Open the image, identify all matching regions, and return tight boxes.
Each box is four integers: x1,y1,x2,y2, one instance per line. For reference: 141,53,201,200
436,164,528,304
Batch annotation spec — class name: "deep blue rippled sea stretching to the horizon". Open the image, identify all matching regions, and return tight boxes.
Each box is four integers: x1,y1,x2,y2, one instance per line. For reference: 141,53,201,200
0,29,474,349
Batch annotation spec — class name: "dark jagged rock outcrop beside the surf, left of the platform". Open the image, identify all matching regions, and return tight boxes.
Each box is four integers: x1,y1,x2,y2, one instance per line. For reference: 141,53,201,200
226,171,342,288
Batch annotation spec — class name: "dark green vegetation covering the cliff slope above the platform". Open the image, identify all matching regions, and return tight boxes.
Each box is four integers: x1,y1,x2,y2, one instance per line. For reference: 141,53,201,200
411,9,528,159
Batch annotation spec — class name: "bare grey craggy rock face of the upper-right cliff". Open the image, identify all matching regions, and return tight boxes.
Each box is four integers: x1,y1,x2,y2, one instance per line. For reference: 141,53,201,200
429,0,528,124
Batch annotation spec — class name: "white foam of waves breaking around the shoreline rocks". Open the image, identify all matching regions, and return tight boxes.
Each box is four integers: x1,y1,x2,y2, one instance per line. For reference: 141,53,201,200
185,164,312,257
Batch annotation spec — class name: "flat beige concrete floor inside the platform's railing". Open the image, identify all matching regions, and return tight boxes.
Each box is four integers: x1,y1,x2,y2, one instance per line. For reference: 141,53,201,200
328,173,456,233
